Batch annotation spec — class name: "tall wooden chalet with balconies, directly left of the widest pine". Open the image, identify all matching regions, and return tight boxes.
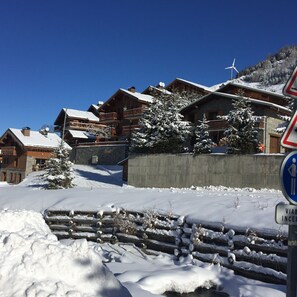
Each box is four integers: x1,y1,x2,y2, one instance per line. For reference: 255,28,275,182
99,87,153,141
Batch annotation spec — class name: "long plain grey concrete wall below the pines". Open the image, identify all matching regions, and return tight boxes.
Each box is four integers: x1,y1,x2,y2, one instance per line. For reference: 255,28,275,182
128,154,284,189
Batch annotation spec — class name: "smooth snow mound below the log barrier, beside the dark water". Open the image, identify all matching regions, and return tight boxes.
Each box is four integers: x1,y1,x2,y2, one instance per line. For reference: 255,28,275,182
94,244,221,296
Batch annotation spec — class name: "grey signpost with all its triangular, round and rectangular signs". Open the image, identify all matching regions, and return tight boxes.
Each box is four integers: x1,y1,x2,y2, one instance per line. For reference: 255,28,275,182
275,67,297,297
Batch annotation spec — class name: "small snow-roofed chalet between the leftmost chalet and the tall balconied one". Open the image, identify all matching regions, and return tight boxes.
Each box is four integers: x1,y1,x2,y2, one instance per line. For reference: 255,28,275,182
54,106,113,146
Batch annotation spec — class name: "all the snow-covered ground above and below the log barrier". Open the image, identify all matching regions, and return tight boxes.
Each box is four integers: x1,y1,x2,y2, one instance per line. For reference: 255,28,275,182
0,166,287,297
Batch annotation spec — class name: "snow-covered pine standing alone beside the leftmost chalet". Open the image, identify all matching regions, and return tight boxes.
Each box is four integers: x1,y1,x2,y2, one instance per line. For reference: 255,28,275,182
45,141,74,189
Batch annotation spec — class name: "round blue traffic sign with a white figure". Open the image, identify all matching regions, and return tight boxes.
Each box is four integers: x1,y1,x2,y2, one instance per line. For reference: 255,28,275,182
280,151,297,205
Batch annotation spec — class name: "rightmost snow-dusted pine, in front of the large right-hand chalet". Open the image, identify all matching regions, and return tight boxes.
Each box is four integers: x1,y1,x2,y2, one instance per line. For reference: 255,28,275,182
219,94,259,154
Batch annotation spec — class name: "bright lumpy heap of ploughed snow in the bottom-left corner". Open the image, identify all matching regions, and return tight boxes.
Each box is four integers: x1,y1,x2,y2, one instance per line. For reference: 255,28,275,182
0,210,131,297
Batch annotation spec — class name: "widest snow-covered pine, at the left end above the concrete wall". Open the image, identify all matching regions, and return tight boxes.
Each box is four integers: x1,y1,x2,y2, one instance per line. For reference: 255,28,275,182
131,93,190,153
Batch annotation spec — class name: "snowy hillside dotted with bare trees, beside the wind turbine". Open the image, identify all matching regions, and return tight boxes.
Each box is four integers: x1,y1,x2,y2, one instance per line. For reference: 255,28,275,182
234,45,297,93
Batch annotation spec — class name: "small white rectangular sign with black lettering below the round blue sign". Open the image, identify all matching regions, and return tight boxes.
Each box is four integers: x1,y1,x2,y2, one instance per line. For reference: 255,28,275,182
275,203,297,225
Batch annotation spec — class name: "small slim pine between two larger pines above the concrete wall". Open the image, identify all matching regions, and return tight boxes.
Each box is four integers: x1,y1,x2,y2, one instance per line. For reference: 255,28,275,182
193,114,215,155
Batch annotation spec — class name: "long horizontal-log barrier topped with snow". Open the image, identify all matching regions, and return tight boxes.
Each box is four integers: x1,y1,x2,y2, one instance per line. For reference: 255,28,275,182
44,210,287,284
